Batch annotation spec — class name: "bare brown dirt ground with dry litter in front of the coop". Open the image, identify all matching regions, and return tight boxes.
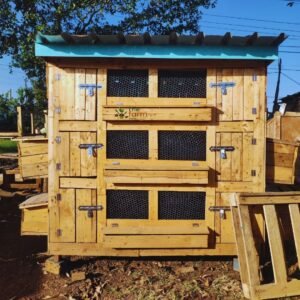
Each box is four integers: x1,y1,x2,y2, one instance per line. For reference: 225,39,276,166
0,192,243,300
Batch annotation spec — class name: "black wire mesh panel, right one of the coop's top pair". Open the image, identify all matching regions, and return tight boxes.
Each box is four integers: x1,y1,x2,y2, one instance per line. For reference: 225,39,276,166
158,70,206,98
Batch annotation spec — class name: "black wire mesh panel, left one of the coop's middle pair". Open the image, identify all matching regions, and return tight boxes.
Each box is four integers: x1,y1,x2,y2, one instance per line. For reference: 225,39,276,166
106,130,149,159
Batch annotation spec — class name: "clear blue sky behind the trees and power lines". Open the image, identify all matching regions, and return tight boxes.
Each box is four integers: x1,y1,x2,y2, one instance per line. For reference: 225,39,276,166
0,0,300,111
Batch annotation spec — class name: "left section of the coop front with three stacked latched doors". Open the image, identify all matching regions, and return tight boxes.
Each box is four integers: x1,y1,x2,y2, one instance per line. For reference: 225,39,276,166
48,66,101,244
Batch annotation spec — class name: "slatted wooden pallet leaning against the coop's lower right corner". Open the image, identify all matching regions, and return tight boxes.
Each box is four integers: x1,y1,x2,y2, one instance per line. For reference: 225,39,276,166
231,192,300,299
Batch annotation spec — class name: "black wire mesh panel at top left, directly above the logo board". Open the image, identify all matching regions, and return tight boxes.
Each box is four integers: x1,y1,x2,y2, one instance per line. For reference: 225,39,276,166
107,70,148,97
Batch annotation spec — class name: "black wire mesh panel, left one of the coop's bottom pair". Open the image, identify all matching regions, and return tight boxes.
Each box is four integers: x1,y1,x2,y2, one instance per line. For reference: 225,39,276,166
106,190,149,219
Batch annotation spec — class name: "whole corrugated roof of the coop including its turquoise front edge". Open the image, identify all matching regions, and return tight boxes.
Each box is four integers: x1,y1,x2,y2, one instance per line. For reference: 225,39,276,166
35,33,286,60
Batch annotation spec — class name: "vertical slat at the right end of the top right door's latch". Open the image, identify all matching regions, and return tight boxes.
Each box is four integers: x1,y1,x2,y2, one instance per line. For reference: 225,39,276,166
232,69,244,121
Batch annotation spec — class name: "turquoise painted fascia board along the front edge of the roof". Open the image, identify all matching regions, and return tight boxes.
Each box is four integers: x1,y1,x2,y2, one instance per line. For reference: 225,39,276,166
35,43,278,60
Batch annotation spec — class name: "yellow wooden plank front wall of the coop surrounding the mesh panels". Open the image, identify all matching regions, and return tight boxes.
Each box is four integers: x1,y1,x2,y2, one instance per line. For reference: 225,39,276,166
48,62,266,255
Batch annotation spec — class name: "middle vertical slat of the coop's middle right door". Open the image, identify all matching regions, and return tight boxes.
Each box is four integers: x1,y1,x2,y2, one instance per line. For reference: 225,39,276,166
231,133,243,181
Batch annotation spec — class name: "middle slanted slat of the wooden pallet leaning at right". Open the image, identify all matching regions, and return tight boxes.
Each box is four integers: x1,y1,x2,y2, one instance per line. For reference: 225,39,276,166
263,205,288,283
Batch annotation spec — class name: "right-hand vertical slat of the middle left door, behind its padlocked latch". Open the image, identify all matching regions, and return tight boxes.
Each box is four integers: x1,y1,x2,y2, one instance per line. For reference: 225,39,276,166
80,132,96,177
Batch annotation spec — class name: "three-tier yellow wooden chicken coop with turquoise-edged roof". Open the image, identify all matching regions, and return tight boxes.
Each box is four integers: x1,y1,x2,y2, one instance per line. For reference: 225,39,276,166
31,33,285,256
